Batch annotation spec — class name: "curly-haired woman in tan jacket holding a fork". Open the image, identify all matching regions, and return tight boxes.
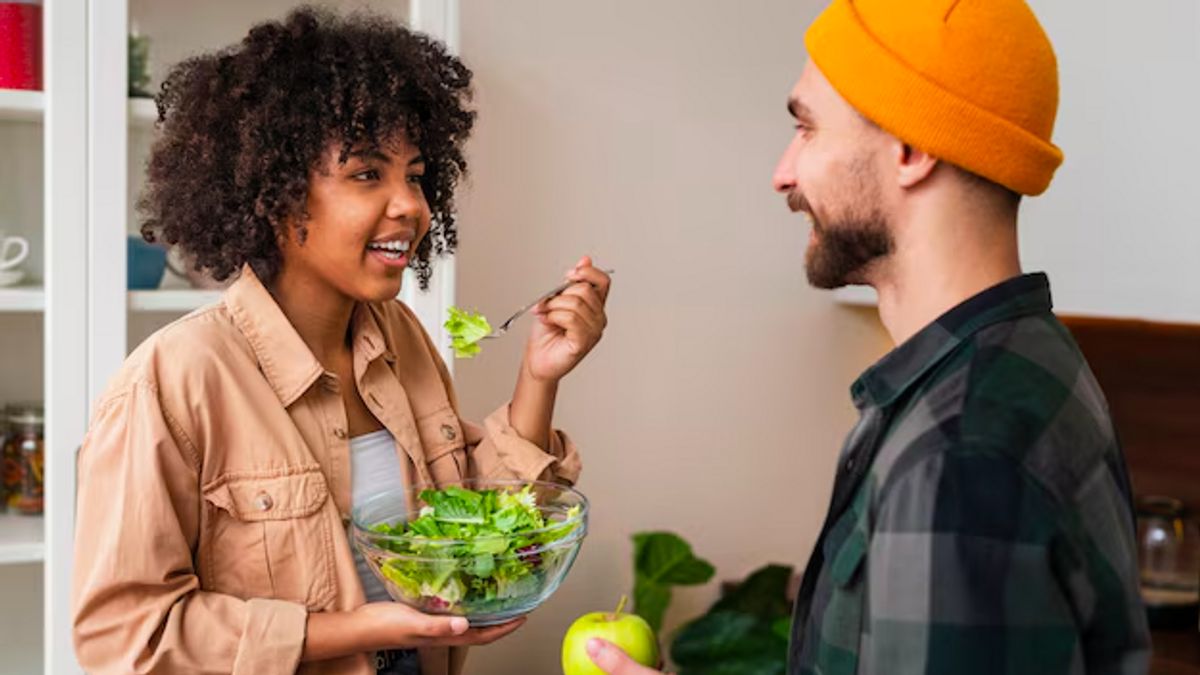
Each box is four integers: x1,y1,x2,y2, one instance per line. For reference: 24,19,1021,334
73,10,608,675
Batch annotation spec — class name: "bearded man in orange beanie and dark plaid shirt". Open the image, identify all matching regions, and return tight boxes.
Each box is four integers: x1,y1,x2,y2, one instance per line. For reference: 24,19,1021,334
589,0,1150,675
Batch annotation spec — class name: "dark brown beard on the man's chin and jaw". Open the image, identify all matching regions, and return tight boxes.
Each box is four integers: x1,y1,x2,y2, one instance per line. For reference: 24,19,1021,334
804,209,895,289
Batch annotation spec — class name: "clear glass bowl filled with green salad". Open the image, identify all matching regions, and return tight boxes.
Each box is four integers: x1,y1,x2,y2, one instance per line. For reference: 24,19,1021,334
352,479,588,626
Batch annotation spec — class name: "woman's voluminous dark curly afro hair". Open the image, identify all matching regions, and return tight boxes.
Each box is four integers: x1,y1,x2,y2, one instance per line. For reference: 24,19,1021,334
138,7,475,289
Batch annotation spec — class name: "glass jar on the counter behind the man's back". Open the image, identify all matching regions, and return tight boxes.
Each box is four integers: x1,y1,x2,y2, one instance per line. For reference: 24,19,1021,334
1138,496,1200,631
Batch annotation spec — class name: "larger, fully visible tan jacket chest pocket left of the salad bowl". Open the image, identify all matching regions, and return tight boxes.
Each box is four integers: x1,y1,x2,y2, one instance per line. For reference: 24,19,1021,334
200,465,336,610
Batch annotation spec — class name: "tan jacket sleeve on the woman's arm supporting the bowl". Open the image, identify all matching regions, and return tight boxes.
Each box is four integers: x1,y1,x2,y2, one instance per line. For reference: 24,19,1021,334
72,382,307,675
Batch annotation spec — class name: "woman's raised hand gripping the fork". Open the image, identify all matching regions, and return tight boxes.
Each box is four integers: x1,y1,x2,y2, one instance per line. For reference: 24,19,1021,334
524,257,611,383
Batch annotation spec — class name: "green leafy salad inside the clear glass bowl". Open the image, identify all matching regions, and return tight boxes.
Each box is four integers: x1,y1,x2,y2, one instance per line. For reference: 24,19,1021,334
371,485,582,614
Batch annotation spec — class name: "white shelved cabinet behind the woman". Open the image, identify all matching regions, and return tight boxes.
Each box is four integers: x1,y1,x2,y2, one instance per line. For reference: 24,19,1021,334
0,0,457,675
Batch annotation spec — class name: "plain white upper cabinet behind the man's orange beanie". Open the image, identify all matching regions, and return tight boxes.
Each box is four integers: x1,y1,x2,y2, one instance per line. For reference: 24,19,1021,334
838,0,1200,323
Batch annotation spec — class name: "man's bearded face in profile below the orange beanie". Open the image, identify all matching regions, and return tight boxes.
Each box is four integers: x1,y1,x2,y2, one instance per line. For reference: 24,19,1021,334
773,61,895,288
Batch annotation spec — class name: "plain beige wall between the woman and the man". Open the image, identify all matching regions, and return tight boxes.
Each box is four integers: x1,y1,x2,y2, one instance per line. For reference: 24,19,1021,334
457,0,887,675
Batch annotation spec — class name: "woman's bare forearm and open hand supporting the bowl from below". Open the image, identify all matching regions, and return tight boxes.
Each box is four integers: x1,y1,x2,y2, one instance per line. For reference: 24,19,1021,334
301,602,526,661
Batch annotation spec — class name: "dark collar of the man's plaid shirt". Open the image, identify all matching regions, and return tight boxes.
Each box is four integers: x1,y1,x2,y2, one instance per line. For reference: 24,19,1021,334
850,273,1052,410
